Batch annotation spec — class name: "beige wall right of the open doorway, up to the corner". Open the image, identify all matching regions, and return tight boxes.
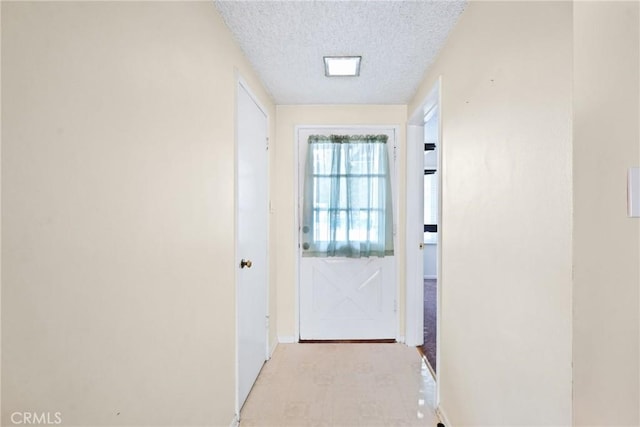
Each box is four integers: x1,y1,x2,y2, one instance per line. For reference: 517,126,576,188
408,2,572,426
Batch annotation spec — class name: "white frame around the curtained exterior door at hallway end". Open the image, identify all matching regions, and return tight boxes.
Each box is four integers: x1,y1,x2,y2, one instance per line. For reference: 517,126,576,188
293,124,401,342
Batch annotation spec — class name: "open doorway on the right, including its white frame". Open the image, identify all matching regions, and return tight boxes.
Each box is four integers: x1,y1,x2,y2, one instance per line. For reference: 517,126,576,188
405,79,445,394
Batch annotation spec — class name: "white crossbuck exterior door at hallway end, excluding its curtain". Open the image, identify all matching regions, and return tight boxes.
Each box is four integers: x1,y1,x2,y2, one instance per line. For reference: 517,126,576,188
298,128,397,340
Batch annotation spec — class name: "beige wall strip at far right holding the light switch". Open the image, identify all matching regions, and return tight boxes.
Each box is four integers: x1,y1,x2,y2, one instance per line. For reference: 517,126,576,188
573,1,640,426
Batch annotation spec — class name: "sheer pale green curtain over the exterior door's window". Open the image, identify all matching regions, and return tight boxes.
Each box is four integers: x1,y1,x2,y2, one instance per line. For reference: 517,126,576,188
302,135,393,258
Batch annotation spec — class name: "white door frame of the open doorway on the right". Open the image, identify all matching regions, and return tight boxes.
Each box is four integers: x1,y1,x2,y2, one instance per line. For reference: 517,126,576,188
405,77,446,405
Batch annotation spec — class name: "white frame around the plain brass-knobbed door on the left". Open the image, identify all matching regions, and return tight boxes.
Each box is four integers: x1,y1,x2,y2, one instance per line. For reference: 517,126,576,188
233,76,271,423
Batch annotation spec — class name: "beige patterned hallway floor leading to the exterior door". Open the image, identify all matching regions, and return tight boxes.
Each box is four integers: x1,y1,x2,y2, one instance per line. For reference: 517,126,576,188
240,344,438,427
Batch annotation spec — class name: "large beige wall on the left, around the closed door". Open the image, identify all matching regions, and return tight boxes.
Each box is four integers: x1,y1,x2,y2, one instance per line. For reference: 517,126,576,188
2,2,275,426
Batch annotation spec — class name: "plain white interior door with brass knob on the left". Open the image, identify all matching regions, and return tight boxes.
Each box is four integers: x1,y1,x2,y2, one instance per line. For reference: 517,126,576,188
236,83,268,410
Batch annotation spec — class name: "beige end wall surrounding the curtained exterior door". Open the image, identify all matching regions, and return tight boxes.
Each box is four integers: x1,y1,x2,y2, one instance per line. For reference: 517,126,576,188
273,105,407,340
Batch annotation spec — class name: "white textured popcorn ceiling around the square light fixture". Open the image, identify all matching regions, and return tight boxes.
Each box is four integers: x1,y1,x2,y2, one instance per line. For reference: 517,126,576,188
215,0,466,104
